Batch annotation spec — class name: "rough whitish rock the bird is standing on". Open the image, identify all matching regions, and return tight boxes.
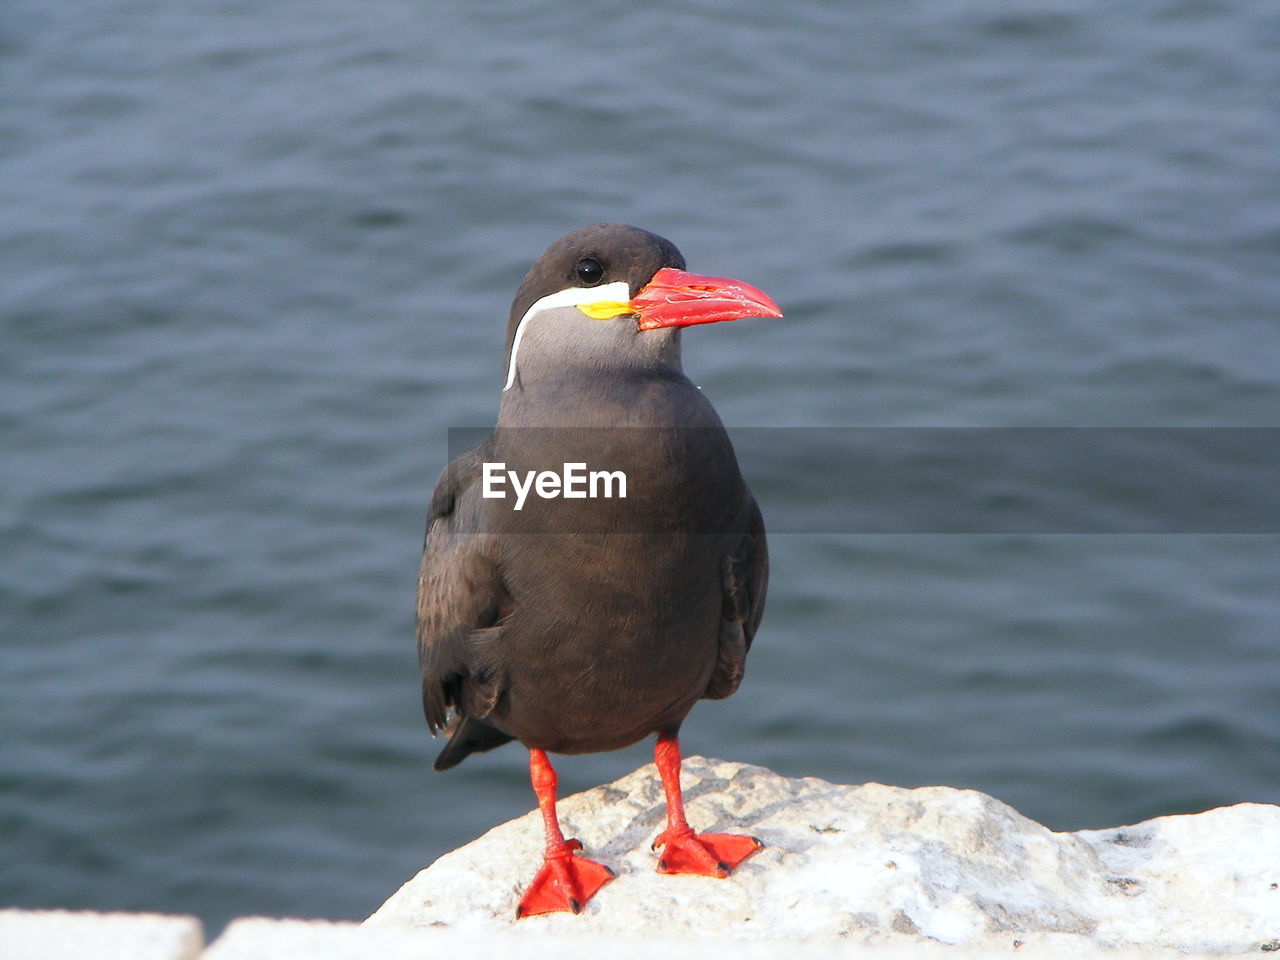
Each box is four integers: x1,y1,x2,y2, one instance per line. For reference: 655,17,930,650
366,756,1280,954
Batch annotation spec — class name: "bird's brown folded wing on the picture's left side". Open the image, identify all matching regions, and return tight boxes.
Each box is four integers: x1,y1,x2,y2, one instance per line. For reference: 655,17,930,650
417,444,511,735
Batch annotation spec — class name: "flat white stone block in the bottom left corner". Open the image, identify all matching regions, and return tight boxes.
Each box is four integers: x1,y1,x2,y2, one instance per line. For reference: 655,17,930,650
0,909,205,960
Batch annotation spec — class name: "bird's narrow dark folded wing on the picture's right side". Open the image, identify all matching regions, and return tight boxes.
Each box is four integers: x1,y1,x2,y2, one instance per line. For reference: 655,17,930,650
704,498,769,700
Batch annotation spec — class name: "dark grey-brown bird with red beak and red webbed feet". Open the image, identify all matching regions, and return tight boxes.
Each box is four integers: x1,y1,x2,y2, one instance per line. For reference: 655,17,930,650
416,223,782,919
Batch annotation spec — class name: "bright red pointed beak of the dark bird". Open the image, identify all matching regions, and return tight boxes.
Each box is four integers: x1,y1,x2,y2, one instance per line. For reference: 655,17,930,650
631,266,782,330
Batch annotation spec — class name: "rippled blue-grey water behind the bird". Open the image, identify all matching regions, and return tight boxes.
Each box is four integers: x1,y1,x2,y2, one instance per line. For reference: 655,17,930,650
0,0,1280,924
